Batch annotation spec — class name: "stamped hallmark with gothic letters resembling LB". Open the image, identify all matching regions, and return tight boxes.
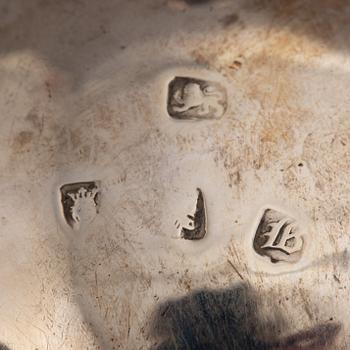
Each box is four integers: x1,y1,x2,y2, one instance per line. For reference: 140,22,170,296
253,209,304,263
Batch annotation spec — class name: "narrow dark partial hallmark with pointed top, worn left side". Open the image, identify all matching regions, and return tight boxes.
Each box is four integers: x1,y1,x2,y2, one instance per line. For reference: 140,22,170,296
181,188,207,240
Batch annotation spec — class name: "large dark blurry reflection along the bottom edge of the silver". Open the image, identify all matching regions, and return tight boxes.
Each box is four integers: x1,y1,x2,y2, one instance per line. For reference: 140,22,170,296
150,283,341,350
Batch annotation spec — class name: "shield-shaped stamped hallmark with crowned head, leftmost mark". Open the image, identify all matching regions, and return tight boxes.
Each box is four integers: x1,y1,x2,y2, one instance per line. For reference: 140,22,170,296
60,181,101,230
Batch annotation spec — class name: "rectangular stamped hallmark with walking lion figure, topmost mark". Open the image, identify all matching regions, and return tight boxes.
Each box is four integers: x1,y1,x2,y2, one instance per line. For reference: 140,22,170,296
168,77,227,119
